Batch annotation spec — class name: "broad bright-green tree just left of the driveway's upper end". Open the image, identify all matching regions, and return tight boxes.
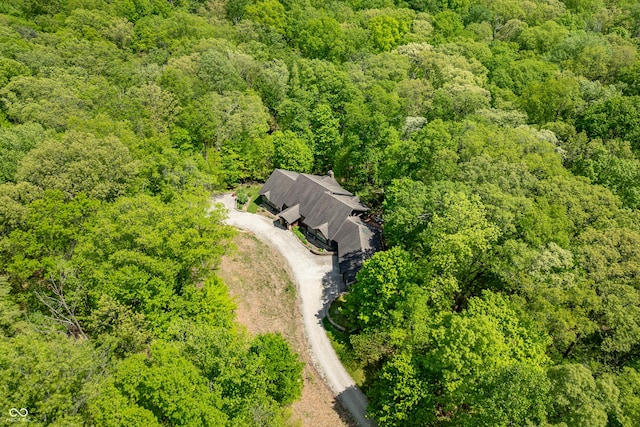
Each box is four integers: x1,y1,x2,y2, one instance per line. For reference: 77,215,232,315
74,195,231,328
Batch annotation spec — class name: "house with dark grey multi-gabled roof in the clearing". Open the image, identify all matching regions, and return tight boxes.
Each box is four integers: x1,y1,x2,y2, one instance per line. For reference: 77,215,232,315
259,169,381,285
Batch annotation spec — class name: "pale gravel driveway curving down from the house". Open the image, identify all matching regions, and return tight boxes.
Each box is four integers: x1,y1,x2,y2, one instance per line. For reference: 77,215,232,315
213,194,375,427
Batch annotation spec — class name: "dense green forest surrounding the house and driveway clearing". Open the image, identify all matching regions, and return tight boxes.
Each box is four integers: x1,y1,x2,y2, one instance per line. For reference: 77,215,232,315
0,0,640,427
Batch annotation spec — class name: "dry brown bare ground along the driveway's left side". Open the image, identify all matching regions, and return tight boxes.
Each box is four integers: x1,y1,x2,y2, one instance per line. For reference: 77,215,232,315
218,232,355,427
